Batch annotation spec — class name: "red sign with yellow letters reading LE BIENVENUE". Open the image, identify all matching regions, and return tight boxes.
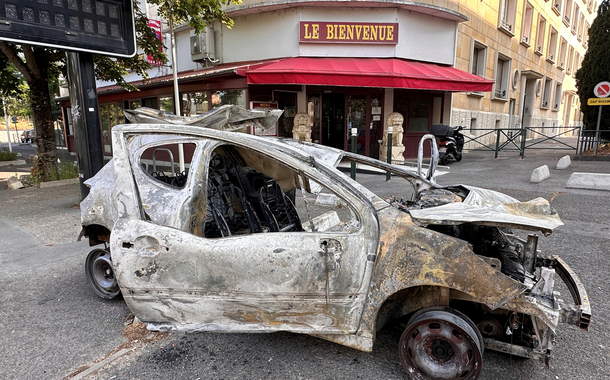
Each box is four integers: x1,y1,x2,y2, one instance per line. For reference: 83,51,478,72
299,21,398,45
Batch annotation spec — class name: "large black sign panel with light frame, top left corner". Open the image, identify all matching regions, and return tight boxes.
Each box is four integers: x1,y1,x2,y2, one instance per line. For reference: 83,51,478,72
0,0,136,57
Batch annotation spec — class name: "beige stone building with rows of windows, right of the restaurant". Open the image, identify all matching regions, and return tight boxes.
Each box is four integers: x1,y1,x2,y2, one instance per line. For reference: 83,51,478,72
451,0,597,137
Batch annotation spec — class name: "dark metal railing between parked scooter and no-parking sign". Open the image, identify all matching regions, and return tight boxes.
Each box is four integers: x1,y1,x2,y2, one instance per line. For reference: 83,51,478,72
464,126,581,158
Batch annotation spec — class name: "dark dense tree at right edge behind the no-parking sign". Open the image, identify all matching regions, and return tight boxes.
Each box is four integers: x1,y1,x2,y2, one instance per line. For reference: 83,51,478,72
576,0,610,136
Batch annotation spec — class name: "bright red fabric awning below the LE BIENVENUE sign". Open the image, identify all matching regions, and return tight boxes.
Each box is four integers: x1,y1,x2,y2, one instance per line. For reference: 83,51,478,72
238,57,494,92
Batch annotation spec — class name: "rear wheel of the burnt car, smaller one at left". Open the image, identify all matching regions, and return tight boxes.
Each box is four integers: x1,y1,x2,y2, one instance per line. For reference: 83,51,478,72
85,249,121,299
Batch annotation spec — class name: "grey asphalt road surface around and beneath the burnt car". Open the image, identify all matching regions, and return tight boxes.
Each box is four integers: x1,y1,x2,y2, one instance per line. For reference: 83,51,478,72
0,146,610,380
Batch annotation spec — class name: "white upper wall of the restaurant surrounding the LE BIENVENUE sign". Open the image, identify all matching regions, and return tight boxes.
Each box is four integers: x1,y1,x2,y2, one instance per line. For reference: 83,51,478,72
98,7,457,88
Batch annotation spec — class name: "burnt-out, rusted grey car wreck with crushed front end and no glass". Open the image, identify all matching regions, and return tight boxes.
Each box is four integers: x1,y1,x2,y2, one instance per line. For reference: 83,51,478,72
81,105,591,379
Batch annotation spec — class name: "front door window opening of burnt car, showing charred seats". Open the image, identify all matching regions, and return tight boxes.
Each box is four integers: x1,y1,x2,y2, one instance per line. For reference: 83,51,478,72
202,145,360,238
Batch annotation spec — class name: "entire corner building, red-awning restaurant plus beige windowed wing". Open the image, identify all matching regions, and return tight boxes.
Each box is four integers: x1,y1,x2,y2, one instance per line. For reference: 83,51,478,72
63,0,598,158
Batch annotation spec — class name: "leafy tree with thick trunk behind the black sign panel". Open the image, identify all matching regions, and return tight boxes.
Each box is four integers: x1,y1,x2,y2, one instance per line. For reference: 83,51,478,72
0,0,241,180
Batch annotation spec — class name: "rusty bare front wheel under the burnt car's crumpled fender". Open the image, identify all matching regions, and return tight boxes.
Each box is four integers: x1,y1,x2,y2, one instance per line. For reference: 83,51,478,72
399,308,484,380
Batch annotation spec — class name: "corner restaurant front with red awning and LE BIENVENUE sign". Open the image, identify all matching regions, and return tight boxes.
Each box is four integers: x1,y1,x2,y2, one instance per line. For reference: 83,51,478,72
59,0,494,158
